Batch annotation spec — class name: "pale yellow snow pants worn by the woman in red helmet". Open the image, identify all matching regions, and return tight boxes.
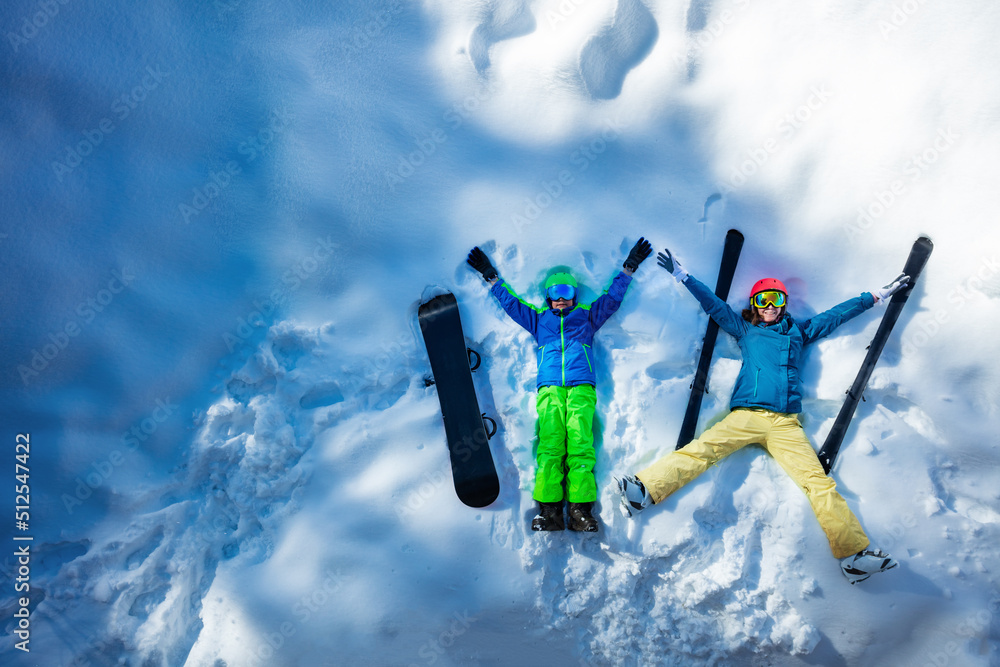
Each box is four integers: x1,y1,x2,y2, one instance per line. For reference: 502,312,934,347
636,408,868,558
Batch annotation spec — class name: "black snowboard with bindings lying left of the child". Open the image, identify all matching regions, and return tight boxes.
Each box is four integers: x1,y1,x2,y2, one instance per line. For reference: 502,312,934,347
417,292,500,507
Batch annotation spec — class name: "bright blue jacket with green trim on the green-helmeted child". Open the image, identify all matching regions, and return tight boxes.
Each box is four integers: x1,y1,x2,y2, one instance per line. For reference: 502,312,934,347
490,272,632,389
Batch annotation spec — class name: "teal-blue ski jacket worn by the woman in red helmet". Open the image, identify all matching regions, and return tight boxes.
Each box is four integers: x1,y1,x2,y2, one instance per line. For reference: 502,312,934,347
684,275,875,413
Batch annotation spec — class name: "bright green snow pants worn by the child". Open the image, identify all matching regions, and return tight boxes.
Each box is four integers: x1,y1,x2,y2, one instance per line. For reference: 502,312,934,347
532,384,597,503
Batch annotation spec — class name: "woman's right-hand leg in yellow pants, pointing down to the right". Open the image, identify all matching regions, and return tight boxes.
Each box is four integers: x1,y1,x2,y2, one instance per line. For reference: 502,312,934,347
764,414,868,558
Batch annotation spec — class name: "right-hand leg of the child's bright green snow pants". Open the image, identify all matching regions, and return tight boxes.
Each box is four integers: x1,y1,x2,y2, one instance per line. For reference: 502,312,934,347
566,384,597,503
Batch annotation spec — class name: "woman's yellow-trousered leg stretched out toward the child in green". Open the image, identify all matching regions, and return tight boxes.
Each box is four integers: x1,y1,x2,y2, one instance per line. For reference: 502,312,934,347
636,410,768,503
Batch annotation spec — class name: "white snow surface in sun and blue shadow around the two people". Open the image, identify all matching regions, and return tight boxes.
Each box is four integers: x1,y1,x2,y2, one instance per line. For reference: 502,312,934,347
0,0,1000,667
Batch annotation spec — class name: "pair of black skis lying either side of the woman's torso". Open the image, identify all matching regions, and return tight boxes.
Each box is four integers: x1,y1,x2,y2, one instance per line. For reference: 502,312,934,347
676,229,934,474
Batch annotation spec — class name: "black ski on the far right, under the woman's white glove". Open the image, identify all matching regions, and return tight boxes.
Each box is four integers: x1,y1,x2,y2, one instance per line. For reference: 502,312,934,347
819,236,934,474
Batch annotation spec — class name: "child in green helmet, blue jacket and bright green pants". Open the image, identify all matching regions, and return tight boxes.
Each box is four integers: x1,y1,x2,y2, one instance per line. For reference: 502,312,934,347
467,238,652,532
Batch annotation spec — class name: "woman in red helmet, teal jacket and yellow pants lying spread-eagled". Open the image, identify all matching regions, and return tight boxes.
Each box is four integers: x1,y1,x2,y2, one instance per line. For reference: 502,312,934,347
615,245,909,584
